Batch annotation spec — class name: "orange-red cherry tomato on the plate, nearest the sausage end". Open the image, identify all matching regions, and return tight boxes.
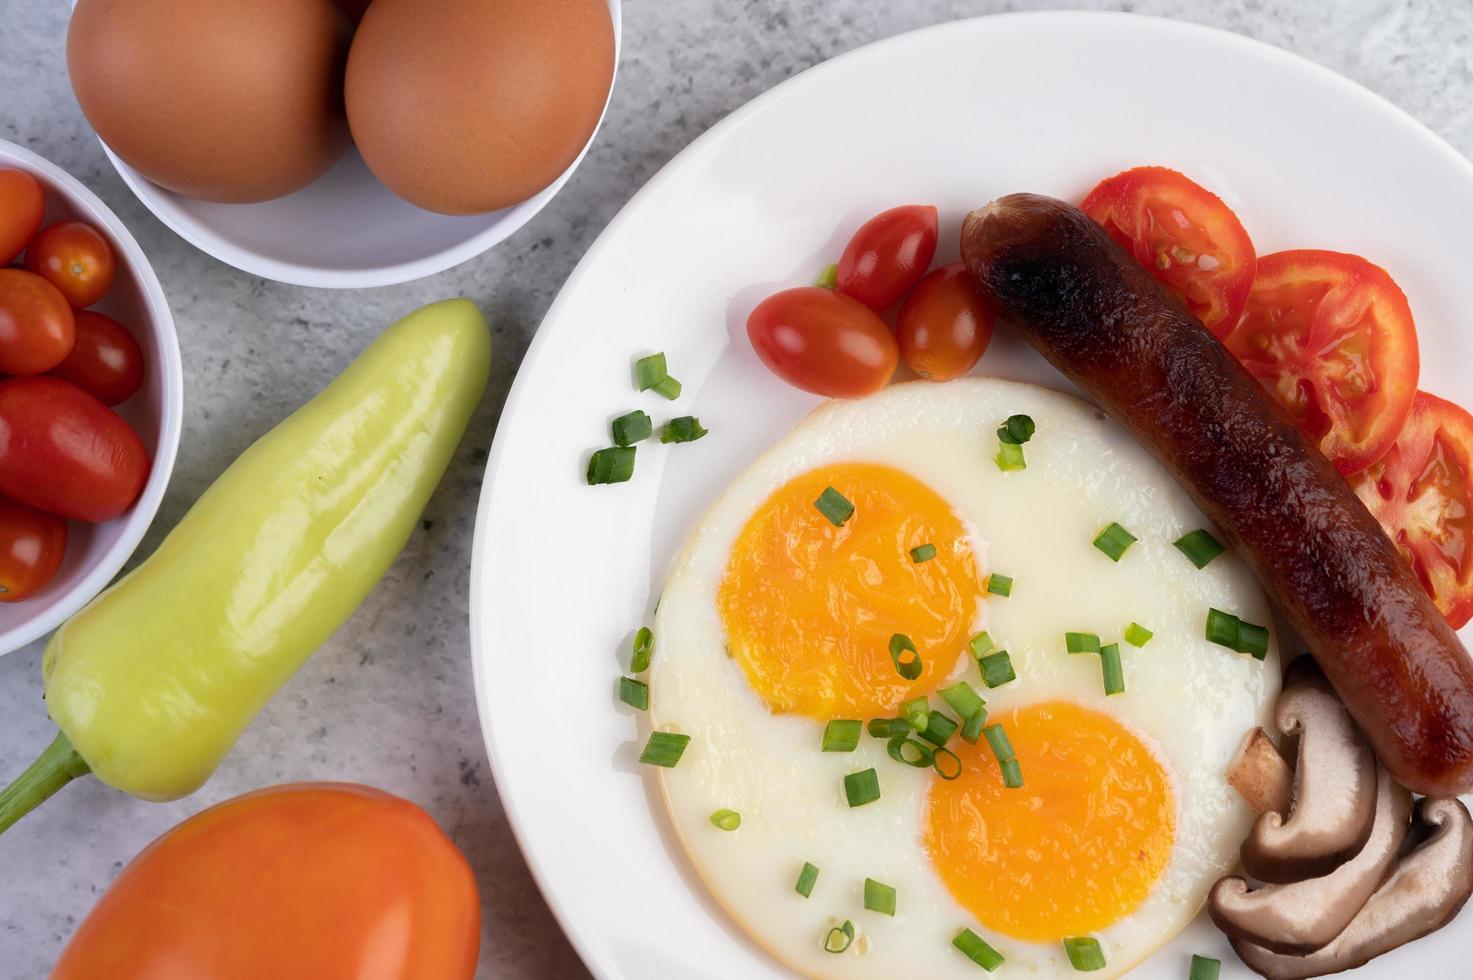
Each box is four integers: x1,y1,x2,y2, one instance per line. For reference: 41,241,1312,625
896,262,994,382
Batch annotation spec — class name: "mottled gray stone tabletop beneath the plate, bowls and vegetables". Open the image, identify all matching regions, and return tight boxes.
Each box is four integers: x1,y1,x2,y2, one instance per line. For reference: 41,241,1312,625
0,0,1473,977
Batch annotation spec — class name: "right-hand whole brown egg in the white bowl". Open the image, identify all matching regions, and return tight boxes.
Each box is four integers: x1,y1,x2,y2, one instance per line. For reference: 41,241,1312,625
348,0,614,214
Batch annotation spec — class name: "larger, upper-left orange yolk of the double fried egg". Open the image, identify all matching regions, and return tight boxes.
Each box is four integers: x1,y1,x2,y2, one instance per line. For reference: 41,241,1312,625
717,463,982,719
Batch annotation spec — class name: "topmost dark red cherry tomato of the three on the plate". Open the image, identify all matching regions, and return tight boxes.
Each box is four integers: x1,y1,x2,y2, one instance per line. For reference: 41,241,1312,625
837,205,937,309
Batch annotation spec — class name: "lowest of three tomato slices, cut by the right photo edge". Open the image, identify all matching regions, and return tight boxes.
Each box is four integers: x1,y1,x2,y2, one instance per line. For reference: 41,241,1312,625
1351,392,1473,629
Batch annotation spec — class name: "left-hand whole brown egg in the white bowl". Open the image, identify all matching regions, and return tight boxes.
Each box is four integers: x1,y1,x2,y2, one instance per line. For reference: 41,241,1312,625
66,0,348,203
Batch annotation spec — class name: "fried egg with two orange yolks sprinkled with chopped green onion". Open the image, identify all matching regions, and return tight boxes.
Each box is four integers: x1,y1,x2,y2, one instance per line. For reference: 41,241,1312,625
648,379,1280,980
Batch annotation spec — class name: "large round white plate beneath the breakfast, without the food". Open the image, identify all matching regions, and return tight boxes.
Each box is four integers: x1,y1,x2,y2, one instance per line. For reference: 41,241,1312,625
471,13,1473,980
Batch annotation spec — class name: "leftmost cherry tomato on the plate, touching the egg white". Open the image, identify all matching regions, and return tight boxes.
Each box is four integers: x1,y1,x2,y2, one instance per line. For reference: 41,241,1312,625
747,286,900,398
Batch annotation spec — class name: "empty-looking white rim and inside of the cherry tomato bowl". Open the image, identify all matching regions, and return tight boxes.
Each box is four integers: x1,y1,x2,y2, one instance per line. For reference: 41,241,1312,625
0,140,184,656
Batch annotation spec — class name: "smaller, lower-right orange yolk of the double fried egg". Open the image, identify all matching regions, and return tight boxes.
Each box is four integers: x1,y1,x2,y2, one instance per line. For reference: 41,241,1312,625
925,701,1175,942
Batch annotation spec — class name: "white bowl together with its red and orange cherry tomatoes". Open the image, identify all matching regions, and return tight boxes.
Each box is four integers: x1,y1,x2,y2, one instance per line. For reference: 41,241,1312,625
0,140,184,654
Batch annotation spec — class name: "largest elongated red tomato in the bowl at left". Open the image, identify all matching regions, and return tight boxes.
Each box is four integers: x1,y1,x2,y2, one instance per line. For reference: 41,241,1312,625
0,377,149,522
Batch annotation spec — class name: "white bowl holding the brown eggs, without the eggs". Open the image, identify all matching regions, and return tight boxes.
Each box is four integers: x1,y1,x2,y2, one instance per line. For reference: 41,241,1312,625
87,0,622,289
